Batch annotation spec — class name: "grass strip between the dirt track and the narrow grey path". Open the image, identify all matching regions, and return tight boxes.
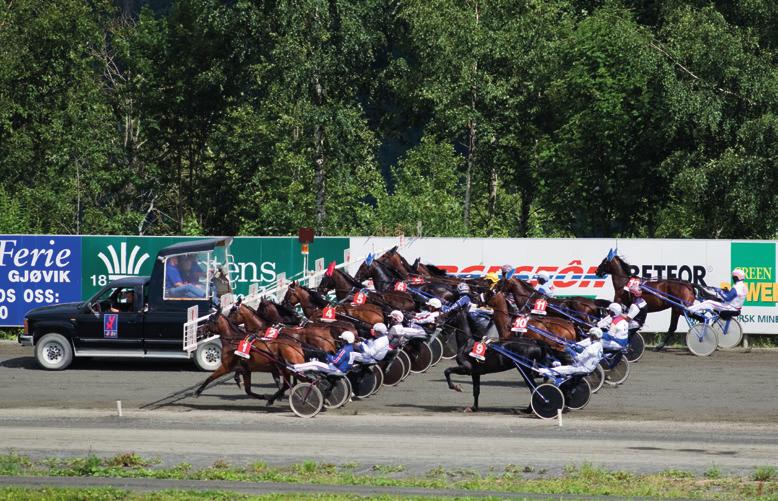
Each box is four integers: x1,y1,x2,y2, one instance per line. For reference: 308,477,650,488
0,452,778,501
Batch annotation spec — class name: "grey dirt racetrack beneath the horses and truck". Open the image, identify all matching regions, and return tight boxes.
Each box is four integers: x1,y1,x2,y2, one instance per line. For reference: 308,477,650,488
0,343,778,471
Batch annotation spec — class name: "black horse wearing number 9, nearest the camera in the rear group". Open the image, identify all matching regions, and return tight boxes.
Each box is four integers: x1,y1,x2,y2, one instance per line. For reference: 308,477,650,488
443,292,545,412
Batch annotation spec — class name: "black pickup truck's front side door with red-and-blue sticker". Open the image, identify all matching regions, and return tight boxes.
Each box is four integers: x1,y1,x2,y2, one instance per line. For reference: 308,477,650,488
74,286,143,355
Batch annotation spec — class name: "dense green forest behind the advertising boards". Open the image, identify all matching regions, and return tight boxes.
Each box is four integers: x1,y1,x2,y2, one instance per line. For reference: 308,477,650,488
0,0,778,239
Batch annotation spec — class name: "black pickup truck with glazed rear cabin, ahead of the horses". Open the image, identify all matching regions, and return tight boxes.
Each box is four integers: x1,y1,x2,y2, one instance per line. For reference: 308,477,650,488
19,237,232,371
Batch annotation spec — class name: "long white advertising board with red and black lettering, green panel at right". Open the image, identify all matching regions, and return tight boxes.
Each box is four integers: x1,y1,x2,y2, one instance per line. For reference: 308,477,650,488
350,237,778,334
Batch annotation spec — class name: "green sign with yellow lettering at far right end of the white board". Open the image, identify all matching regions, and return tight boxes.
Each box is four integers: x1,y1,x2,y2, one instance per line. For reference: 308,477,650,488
730,242,776,306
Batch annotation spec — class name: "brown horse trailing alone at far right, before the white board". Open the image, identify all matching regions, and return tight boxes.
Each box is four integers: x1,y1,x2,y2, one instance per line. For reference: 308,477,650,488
596,251,696,351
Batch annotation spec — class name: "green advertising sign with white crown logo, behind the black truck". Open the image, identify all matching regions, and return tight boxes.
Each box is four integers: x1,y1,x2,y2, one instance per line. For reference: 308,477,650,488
81,236,349,298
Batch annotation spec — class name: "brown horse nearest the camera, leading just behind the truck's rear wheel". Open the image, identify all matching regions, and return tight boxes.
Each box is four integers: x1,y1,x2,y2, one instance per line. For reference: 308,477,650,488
194,308,305,405
